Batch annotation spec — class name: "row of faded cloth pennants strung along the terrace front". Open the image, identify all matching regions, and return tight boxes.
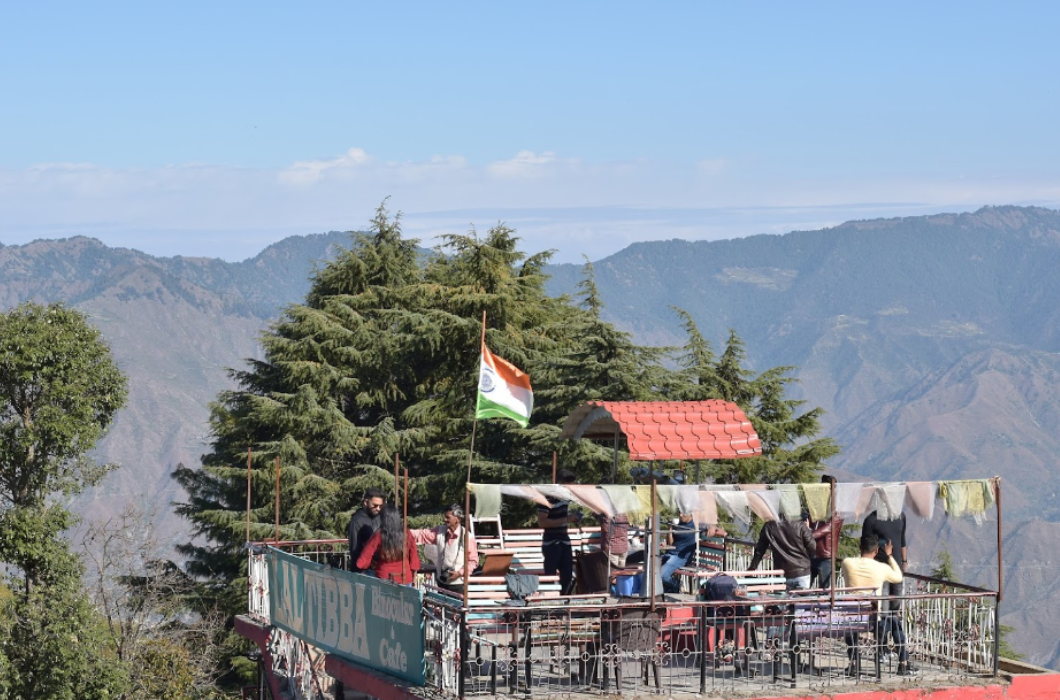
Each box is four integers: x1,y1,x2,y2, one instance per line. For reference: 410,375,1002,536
467,478,996,527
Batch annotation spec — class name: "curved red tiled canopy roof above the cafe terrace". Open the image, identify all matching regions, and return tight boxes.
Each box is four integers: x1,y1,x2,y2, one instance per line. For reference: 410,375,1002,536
560,399,762,461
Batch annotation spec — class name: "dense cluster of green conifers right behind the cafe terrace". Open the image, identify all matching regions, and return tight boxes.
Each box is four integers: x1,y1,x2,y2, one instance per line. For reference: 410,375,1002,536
175,202,843,683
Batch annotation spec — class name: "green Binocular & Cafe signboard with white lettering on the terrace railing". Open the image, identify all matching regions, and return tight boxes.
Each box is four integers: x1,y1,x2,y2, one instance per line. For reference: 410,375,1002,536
268,547,425,685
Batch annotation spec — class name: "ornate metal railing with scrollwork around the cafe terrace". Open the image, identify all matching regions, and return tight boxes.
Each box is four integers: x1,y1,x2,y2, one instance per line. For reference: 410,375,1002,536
248,541,999,700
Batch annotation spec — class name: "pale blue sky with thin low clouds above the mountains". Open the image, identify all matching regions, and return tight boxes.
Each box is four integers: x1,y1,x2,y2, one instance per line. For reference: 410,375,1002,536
0,1,1060,261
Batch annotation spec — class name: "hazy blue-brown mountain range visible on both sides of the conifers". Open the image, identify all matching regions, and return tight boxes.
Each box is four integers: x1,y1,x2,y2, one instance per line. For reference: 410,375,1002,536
0,207,1060,666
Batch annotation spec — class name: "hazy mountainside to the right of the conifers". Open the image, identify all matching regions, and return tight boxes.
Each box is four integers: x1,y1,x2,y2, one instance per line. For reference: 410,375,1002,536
550,207,1060,666
